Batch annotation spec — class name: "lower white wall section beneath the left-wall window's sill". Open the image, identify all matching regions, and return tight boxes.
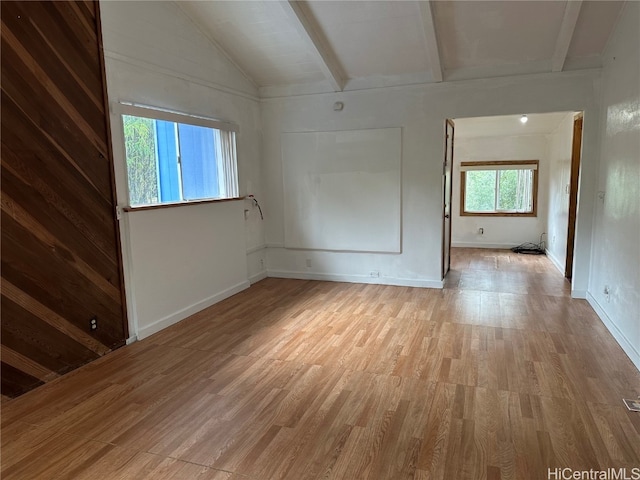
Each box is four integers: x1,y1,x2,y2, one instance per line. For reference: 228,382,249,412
127,200,249,338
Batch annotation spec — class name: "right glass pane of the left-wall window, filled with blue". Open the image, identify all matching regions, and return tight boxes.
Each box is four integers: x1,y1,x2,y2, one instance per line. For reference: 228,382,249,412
178,123,220,200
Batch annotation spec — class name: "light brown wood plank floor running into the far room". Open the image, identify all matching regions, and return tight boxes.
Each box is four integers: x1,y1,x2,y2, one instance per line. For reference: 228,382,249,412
2,249,640,480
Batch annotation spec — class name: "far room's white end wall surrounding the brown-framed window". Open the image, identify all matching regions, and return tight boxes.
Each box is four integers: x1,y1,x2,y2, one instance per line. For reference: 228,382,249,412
451,134,549,248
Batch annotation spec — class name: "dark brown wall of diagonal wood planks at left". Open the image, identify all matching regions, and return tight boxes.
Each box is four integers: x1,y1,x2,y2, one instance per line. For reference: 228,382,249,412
0,1,127,398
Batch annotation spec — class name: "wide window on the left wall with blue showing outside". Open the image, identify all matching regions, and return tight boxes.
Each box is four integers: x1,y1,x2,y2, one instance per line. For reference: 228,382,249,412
120,105,238,207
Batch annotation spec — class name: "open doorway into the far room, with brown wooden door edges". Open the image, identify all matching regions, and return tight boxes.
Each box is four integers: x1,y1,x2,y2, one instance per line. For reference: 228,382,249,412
442,111,582,284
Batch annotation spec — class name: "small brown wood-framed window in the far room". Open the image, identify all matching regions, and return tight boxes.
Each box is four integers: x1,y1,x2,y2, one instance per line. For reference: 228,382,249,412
460,160,538,217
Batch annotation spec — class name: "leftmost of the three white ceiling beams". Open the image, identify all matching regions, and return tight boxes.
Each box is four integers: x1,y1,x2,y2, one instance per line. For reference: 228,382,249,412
281,0,346,92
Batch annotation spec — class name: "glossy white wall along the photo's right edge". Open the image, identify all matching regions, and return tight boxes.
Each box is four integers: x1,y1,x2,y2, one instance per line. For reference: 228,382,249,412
587,2,640,369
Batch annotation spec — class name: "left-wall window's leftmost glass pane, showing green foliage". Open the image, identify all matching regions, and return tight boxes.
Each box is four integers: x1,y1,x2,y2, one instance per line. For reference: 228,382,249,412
122,115,158,205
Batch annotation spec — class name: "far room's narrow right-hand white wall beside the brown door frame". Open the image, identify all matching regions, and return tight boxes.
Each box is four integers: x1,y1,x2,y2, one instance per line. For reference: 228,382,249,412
546,113,574,275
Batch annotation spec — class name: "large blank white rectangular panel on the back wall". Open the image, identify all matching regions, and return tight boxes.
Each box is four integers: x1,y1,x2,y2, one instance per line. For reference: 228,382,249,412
281,128,402,253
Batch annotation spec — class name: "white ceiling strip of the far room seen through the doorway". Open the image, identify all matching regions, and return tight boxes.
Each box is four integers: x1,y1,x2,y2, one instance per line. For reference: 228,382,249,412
454,112,574,138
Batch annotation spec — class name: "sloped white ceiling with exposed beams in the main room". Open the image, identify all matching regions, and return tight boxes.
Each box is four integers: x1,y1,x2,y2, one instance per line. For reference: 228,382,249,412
177,0,624,93
